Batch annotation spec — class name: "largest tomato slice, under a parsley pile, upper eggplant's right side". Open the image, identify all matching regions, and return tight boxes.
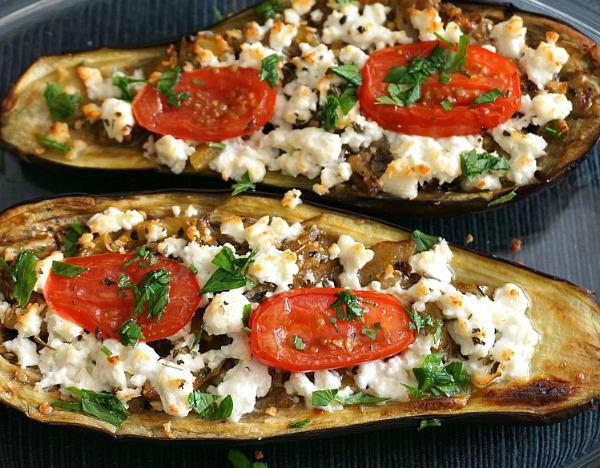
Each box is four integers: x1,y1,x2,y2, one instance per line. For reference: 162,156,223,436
359,41,521,138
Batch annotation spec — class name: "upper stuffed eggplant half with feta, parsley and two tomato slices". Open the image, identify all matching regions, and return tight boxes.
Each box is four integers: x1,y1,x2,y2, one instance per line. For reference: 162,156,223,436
2,0,600,214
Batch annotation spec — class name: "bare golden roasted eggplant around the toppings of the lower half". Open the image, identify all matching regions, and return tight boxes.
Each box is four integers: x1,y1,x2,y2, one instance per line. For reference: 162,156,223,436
0,191,600,441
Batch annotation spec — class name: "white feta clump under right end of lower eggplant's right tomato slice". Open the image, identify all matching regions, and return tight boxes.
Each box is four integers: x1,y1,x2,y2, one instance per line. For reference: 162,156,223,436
355,335,433,401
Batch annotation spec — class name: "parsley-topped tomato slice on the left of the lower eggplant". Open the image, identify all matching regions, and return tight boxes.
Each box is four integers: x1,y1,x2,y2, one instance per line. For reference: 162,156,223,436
44,254,201,341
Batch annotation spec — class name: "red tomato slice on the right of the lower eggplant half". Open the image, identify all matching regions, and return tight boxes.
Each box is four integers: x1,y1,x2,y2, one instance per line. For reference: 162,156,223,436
250,288,414,372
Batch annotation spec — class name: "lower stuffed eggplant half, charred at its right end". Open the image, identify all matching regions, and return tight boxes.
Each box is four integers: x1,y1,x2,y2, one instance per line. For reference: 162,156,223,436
0,192,600,440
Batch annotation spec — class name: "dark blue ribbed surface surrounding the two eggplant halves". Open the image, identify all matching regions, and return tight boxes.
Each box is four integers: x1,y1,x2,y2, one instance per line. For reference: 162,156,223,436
0,0,600,468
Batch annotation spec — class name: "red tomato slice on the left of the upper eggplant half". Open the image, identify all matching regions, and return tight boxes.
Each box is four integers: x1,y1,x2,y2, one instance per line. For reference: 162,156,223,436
133,67,276,142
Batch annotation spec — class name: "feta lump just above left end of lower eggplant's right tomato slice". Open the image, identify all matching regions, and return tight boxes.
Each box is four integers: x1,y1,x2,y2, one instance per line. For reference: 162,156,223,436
248,245,300,292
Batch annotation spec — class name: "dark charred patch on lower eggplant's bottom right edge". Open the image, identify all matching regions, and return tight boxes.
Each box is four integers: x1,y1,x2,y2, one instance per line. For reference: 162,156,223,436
482,379,575,406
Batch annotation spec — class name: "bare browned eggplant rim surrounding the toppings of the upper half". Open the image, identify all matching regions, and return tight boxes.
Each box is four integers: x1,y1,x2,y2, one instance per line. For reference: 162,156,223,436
0,0,600,215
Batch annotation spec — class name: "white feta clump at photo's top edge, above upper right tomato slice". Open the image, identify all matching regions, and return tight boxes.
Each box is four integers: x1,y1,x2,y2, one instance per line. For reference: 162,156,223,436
322,3,411,50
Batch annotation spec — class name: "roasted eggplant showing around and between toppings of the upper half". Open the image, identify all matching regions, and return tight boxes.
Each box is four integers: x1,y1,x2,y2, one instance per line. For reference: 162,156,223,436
1,1,600,215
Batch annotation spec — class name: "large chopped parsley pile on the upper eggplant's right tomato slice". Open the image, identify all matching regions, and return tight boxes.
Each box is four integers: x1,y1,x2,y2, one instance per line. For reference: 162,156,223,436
376,34,469,106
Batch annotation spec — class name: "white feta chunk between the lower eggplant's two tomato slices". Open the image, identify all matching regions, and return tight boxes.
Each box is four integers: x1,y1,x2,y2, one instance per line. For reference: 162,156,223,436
203,288,250,335
